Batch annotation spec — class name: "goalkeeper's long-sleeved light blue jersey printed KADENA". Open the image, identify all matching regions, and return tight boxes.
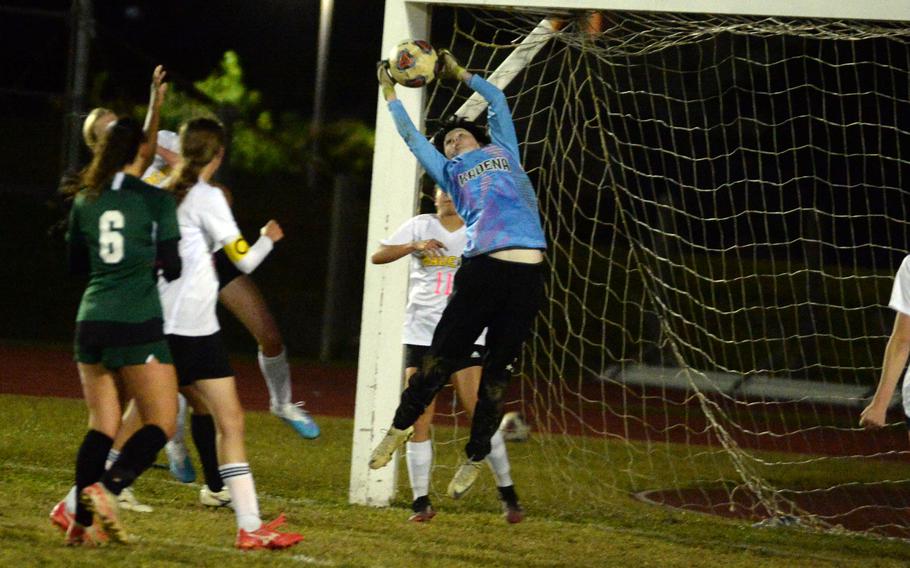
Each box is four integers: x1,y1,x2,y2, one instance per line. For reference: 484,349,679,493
389,75,547,258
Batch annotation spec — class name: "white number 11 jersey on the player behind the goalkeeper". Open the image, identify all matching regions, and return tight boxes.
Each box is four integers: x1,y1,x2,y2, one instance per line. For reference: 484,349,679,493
380,214,486,345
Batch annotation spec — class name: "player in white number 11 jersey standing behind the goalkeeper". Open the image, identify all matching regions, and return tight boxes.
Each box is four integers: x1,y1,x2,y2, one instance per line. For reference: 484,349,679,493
371,187,524,523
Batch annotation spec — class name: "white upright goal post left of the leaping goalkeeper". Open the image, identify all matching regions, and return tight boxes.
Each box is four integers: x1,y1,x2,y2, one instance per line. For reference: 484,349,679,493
349,1,429,506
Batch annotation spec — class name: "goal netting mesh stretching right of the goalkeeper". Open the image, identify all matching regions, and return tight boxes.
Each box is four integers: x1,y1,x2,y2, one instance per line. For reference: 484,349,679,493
416,8,910,536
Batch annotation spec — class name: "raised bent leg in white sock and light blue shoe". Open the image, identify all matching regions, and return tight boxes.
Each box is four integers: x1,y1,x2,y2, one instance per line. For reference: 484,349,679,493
218,274,320,439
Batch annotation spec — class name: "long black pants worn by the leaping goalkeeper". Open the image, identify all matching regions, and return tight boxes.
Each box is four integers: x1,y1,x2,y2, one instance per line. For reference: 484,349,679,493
392,255,544,461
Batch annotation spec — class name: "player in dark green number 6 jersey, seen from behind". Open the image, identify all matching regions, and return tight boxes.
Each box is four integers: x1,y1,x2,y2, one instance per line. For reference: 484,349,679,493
66,118,181,545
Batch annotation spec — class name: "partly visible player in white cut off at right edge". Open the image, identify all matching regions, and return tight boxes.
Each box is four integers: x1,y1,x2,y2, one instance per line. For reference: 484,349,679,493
859,256,910,430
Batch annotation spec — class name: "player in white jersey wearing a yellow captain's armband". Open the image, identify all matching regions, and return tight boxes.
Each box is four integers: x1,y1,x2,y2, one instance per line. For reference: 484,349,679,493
159,118,303,549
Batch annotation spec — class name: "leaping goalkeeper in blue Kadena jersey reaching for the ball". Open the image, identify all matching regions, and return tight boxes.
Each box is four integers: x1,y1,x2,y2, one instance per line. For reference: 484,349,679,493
370,50,546,499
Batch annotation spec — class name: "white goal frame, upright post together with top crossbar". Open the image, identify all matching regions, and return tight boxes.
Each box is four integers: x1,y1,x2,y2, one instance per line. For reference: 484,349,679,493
348,0,910,507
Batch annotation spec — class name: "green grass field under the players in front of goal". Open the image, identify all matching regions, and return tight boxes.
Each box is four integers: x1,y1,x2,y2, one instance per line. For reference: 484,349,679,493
0,395,910,567
